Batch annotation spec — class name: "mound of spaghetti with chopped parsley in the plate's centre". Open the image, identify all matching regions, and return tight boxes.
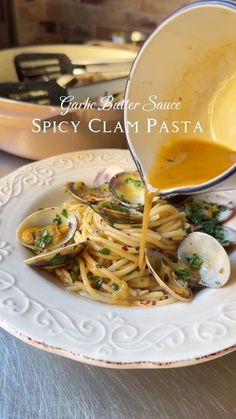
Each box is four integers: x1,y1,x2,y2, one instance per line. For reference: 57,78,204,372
55,199,188,306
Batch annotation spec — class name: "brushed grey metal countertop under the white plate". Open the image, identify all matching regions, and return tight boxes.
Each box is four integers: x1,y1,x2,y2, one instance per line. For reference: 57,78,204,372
0,152,236,419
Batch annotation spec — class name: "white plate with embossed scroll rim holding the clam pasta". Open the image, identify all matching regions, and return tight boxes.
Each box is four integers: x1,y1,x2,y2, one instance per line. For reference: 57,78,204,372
0,149,236,368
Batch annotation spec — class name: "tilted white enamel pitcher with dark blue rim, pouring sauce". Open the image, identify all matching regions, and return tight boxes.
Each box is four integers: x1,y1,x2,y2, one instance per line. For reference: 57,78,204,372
125,1,236,195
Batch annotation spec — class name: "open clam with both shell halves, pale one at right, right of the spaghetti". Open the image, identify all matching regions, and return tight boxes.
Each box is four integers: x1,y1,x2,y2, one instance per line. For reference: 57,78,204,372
146,232,230,302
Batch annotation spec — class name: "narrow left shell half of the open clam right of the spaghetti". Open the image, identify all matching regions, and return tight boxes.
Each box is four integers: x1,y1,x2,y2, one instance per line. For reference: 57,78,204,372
146,248,192,302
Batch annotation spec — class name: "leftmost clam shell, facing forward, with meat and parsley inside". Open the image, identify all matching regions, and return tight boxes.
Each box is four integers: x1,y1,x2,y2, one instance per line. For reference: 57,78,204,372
16,207,77,253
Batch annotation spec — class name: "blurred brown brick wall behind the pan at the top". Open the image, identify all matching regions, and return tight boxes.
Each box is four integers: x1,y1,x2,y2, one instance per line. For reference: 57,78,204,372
15,0,199,45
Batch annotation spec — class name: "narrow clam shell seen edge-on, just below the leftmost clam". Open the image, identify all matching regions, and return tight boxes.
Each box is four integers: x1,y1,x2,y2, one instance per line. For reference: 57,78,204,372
25,242,87,269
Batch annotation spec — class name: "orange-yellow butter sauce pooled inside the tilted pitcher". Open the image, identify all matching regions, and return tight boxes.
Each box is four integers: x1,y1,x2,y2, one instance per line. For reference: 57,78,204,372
148,139,236,190
